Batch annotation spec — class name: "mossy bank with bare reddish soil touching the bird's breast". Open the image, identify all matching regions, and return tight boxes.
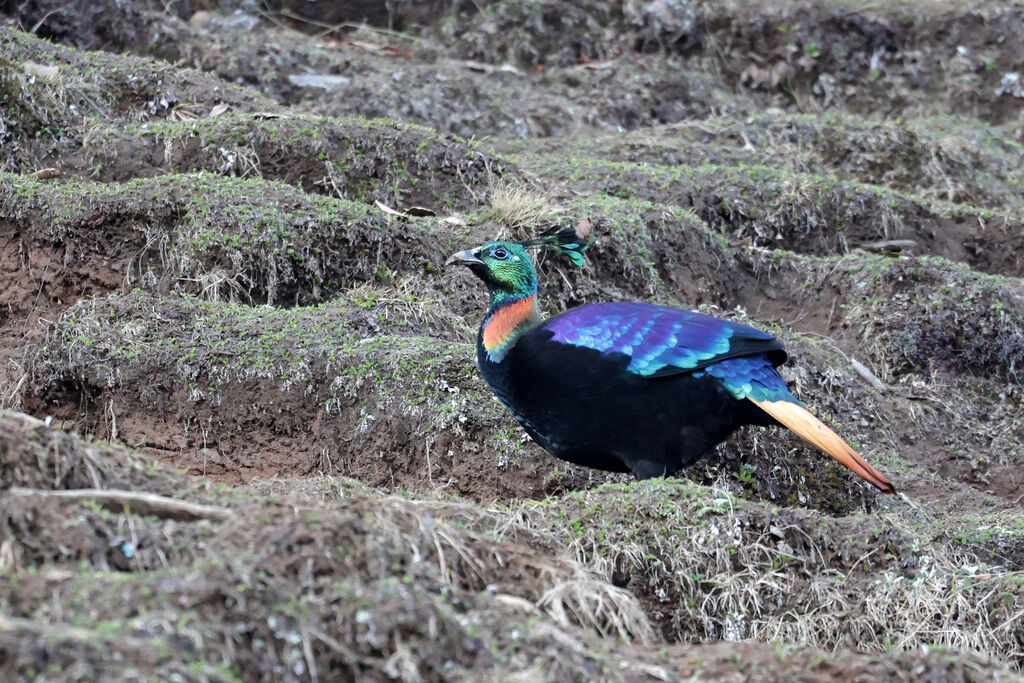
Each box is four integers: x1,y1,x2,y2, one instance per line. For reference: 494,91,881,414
30,290,622,501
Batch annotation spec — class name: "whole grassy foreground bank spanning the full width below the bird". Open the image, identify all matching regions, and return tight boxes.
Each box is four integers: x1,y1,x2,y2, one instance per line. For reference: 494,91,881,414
0,414,1021,679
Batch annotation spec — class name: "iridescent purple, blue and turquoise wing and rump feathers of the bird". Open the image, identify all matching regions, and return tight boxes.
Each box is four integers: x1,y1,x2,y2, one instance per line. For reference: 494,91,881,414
541,303,792,400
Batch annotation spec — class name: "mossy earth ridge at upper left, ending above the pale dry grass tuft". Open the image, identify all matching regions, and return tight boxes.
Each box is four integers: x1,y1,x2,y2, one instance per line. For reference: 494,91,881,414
73,113,514,209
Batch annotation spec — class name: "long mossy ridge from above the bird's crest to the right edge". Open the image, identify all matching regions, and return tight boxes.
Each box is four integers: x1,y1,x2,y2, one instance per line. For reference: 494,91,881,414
515,156,1024,276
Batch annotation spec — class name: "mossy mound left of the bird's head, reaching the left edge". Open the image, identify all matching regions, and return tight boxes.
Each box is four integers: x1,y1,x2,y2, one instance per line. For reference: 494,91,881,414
0,173,467,303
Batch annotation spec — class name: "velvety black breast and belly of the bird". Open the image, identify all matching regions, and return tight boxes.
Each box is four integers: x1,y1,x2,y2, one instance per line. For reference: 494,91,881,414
478,329,757,477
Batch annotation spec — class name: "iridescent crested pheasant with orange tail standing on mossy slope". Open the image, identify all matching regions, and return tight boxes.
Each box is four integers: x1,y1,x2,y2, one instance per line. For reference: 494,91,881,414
445,227,896,494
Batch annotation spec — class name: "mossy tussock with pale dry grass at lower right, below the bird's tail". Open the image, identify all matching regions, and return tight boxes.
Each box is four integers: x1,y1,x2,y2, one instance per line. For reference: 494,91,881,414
489,482,1024,666
